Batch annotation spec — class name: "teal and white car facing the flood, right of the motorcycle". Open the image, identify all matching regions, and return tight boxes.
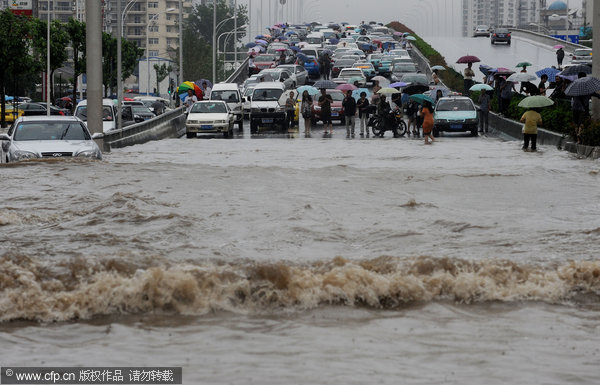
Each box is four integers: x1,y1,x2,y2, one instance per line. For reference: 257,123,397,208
433,96,478,137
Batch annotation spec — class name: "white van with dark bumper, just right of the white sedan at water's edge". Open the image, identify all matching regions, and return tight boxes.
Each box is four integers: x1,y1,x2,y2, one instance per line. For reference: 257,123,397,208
250,82,286,133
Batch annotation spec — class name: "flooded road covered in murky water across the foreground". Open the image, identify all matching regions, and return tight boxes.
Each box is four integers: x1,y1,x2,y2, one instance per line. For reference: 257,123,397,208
0,128,600,384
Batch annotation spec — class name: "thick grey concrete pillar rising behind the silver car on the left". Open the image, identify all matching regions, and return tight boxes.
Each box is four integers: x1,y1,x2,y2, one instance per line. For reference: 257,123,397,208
85,0,102,134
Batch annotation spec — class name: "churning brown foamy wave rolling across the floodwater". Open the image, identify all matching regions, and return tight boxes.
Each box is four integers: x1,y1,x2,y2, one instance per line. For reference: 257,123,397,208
0,254,600,322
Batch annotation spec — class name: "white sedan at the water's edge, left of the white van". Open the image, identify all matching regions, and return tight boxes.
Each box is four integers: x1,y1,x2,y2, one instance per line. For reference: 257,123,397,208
185,100,235,138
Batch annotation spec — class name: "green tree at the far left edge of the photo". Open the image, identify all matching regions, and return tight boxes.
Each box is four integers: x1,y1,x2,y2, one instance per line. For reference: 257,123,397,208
0,9,32,127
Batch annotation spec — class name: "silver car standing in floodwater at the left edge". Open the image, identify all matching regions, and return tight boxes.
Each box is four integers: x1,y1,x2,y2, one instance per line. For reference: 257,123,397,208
0,116,102,163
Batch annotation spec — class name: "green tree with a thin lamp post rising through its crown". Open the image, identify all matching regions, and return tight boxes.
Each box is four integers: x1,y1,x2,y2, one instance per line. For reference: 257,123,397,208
31,18,69,100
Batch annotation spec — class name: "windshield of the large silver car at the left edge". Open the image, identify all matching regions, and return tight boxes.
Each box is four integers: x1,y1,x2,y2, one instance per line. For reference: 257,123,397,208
13,121,91,141
